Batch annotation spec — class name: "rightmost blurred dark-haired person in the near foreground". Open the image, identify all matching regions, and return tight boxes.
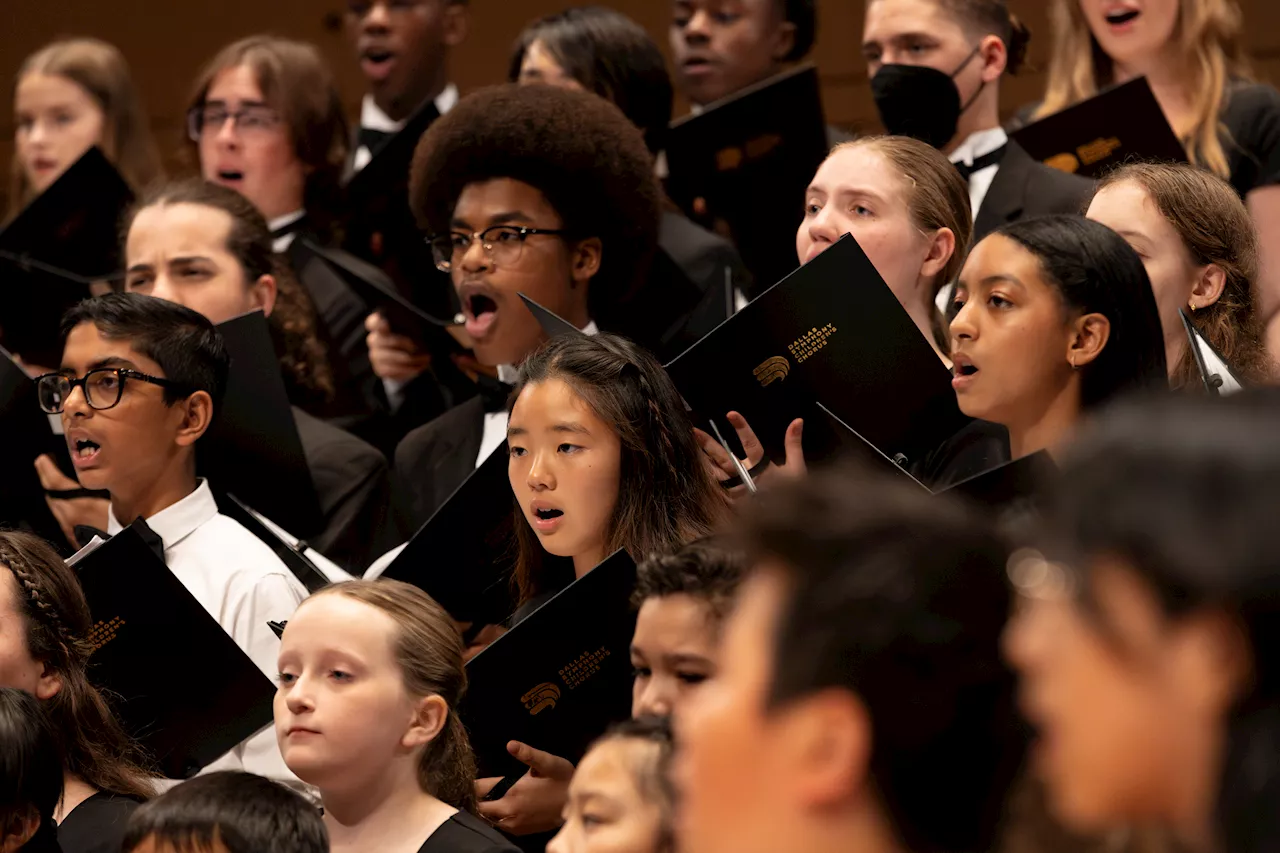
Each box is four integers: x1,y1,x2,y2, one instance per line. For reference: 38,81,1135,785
1005,391,1280,853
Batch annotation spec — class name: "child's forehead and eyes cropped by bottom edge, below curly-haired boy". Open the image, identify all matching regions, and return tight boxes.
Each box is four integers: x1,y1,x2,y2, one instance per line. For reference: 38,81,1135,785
547,717,676,853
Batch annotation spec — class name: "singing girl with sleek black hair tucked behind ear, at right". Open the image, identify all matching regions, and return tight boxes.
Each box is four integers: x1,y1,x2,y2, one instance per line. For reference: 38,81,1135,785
951,216,1169,459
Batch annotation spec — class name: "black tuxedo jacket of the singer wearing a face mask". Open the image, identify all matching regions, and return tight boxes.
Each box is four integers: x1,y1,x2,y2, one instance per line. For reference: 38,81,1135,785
973,140,1093,239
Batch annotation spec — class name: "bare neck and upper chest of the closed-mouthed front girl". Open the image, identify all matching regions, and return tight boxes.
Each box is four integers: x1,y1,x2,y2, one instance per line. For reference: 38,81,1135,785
320,756,458,852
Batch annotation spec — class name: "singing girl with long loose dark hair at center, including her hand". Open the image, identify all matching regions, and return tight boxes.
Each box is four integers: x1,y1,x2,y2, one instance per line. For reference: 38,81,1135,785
476,333,728,835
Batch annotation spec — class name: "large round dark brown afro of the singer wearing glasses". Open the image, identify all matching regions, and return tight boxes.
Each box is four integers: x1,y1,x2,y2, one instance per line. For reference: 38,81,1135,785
410,83,662,316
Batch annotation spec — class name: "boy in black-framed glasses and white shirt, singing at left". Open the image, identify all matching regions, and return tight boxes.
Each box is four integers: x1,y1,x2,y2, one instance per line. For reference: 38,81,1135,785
36,293,306,784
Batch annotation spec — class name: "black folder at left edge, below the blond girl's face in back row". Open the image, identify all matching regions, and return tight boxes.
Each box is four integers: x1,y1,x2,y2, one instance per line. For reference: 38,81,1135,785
0,149,133,368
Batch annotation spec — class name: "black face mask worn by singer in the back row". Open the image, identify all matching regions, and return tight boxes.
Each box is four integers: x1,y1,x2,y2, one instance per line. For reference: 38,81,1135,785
872,46,987,149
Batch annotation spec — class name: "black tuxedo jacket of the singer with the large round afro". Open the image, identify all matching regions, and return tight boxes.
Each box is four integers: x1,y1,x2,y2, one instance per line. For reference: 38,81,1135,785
392,397,484,533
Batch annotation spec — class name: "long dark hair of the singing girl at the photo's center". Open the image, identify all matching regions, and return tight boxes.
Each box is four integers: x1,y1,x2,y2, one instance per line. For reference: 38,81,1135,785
511,334,728,602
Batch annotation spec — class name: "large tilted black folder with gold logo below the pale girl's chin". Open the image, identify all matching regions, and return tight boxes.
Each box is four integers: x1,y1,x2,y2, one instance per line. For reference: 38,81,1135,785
667,234,969,467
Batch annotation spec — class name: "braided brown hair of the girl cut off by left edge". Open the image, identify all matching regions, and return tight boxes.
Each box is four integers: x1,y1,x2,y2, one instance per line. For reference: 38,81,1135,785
0,530,155,800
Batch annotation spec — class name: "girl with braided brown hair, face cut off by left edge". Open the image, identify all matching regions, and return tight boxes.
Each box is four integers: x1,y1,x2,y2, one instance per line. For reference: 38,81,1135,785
0,530,155,853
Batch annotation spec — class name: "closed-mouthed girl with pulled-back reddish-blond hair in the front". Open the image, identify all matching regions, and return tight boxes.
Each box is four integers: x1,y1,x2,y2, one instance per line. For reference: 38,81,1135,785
275,580,516,853
